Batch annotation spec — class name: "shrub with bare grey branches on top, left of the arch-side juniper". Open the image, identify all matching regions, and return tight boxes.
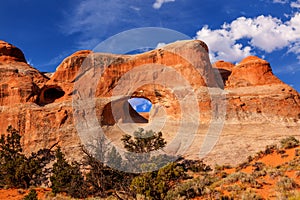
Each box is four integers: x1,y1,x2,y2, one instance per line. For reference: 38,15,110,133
82,136,134,198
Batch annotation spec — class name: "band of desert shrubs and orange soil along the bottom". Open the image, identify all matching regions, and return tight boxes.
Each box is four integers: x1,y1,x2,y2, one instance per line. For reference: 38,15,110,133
0,127,300,200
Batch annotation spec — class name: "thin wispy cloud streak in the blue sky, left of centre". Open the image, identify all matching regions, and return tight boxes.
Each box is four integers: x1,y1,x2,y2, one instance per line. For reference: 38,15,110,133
61,0,129,49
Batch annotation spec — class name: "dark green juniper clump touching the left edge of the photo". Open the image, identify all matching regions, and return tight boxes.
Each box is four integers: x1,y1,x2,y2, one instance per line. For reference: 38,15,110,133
0,126,53,188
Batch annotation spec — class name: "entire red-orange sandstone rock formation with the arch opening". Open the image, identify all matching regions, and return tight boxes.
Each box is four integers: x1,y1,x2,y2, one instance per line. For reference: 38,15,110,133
0,40,300,163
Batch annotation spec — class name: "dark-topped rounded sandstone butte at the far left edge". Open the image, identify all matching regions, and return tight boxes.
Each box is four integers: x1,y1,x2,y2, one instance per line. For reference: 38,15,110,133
0,41,48,106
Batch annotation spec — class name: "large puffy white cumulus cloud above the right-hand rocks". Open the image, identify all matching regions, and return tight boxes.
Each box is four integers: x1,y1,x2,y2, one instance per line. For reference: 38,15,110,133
196,13,300,62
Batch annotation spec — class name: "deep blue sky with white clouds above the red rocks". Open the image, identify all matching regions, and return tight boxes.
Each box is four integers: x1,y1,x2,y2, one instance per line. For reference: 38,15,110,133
0,0,300,91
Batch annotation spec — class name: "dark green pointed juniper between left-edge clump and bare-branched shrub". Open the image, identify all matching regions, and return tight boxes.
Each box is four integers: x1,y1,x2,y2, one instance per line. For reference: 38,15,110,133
50,148,86,198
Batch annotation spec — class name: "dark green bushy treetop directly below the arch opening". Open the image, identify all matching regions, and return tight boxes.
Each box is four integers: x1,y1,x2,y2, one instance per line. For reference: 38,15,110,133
121,128,167,153
